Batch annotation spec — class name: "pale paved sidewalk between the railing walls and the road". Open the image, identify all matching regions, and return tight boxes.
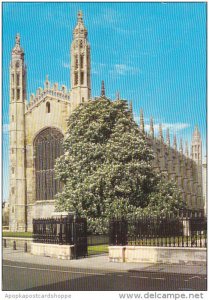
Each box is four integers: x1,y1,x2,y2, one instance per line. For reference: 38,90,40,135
2,248,207,276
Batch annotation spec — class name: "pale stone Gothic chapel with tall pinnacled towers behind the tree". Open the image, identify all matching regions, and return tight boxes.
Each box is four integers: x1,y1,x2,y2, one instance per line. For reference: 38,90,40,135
9,12,204,231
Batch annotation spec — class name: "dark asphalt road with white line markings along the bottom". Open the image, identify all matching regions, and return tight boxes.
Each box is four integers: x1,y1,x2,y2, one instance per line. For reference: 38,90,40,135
2,260,207,291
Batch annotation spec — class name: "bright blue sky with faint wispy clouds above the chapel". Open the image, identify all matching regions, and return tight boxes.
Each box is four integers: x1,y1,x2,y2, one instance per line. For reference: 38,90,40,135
2,2,206,200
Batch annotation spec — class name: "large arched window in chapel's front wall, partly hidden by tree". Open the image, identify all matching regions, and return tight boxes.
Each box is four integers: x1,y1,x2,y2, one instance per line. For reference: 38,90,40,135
34,127,63,200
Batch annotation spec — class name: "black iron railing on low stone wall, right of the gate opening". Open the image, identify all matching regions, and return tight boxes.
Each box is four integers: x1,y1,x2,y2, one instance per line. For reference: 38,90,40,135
109,212,207,248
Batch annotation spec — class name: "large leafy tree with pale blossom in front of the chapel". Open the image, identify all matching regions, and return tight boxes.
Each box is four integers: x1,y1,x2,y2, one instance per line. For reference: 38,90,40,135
56,98,185,233
